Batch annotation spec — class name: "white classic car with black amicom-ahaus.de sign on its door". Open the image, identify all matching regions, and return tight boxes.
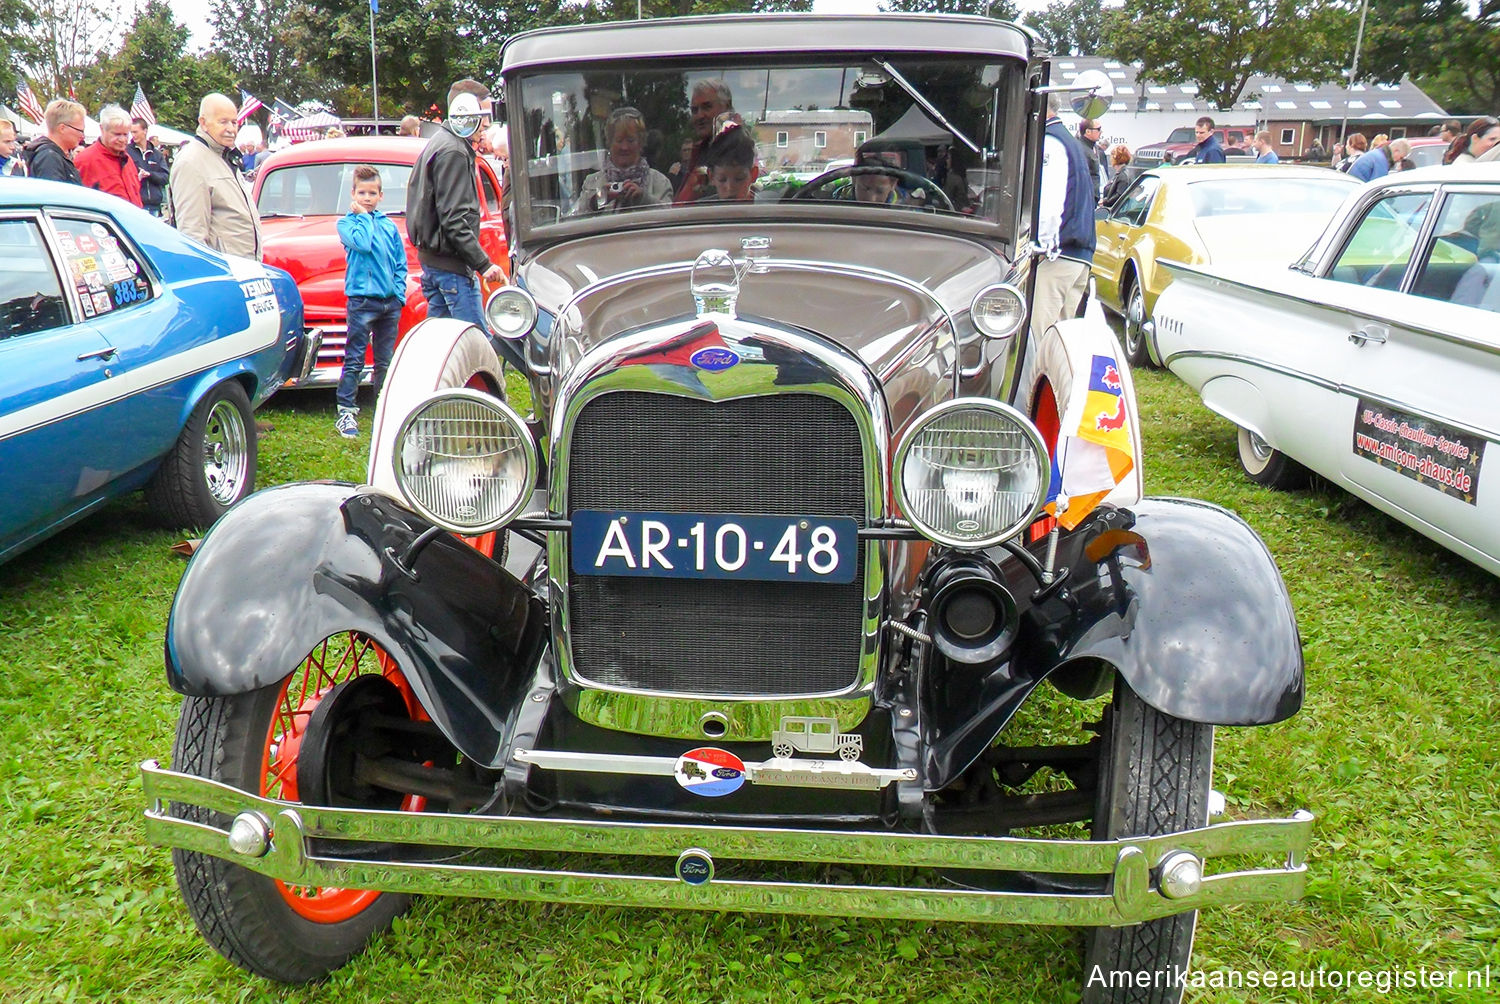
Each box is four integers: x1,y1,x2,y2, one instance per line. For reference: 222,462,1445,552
1148,164,1500,575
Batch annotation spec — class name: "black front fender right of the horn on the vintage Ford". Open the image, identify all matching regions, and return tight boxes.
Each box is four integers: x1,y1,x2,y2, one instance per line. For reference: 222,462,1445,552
1040,498,1304,725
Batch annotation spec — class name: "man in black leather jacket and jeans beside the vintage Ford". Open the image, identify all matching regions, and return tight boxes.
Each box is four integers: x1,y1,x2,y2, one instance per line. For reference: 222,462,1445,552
407,78,506,330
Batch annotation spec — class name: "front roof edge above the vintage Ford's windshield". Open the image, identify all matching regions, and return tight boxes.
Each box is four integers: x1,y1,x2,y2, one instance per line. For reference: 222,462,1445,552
500,14,1034,75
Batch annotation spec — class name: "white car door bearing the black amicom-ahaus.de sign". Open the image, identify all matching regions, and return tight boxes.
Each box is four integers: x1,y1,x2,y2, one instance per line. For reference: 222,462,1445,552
1343,185,1500,561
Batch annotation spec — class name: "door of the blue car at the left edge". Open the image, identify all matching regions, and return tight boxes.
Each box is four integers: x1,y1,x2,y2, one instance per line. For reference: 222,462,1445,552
0,210,129,558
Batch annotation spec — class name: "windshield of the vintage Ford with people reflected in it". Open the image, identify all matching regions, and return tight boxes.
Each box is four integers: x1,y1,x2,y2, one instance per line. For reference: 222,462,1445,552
510,57,1025,231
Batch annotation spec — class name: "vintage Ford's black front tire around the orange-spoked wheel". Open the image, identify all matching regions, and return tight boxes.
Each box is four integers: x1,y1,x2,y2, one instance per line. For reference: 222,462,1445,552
173,633,411,983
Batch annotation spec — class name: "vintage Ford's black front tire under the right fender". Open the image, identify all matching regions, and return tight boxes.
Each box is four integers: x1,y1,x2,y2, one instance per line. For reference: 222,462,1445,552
1083,678,1214,1004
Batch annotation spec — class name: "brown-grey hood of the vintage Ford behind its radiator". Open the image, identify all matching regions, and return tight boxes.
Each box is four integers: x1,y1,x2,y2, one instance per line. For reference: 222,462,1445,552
521,224,1010,378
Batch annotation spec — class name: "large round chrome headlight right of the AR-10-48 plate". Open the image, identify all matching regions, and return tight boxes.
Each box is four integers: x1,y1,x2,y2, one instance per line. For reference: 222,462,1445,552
896,398,1052,548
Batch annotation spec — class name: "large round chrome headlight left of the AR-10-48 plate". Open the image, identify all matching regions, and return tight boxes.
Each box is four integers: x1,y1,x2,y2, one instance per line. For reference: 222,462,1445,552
393,389,537,536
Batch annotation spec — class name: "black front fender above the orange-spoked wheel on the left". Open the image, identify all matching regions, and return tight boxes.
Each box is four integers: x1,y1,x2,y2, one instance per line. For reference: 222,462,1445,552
165,483,546,765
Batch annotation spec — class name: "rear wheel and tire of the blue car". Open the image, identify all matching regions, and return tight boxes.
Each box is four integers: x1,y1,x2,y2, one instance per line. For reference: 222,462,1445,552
146,380,258,530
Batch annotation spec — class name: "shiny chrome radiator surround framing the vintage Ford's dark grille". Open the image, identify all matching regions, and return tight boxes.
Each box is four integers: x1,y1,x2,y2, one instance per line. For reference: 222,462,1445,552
548,315,891,741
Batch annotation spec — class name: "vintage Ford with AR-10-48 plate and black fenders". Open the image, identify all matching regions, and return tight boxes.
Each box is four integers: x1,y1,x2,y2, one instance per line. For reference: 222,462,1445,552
144,15,1311,999
